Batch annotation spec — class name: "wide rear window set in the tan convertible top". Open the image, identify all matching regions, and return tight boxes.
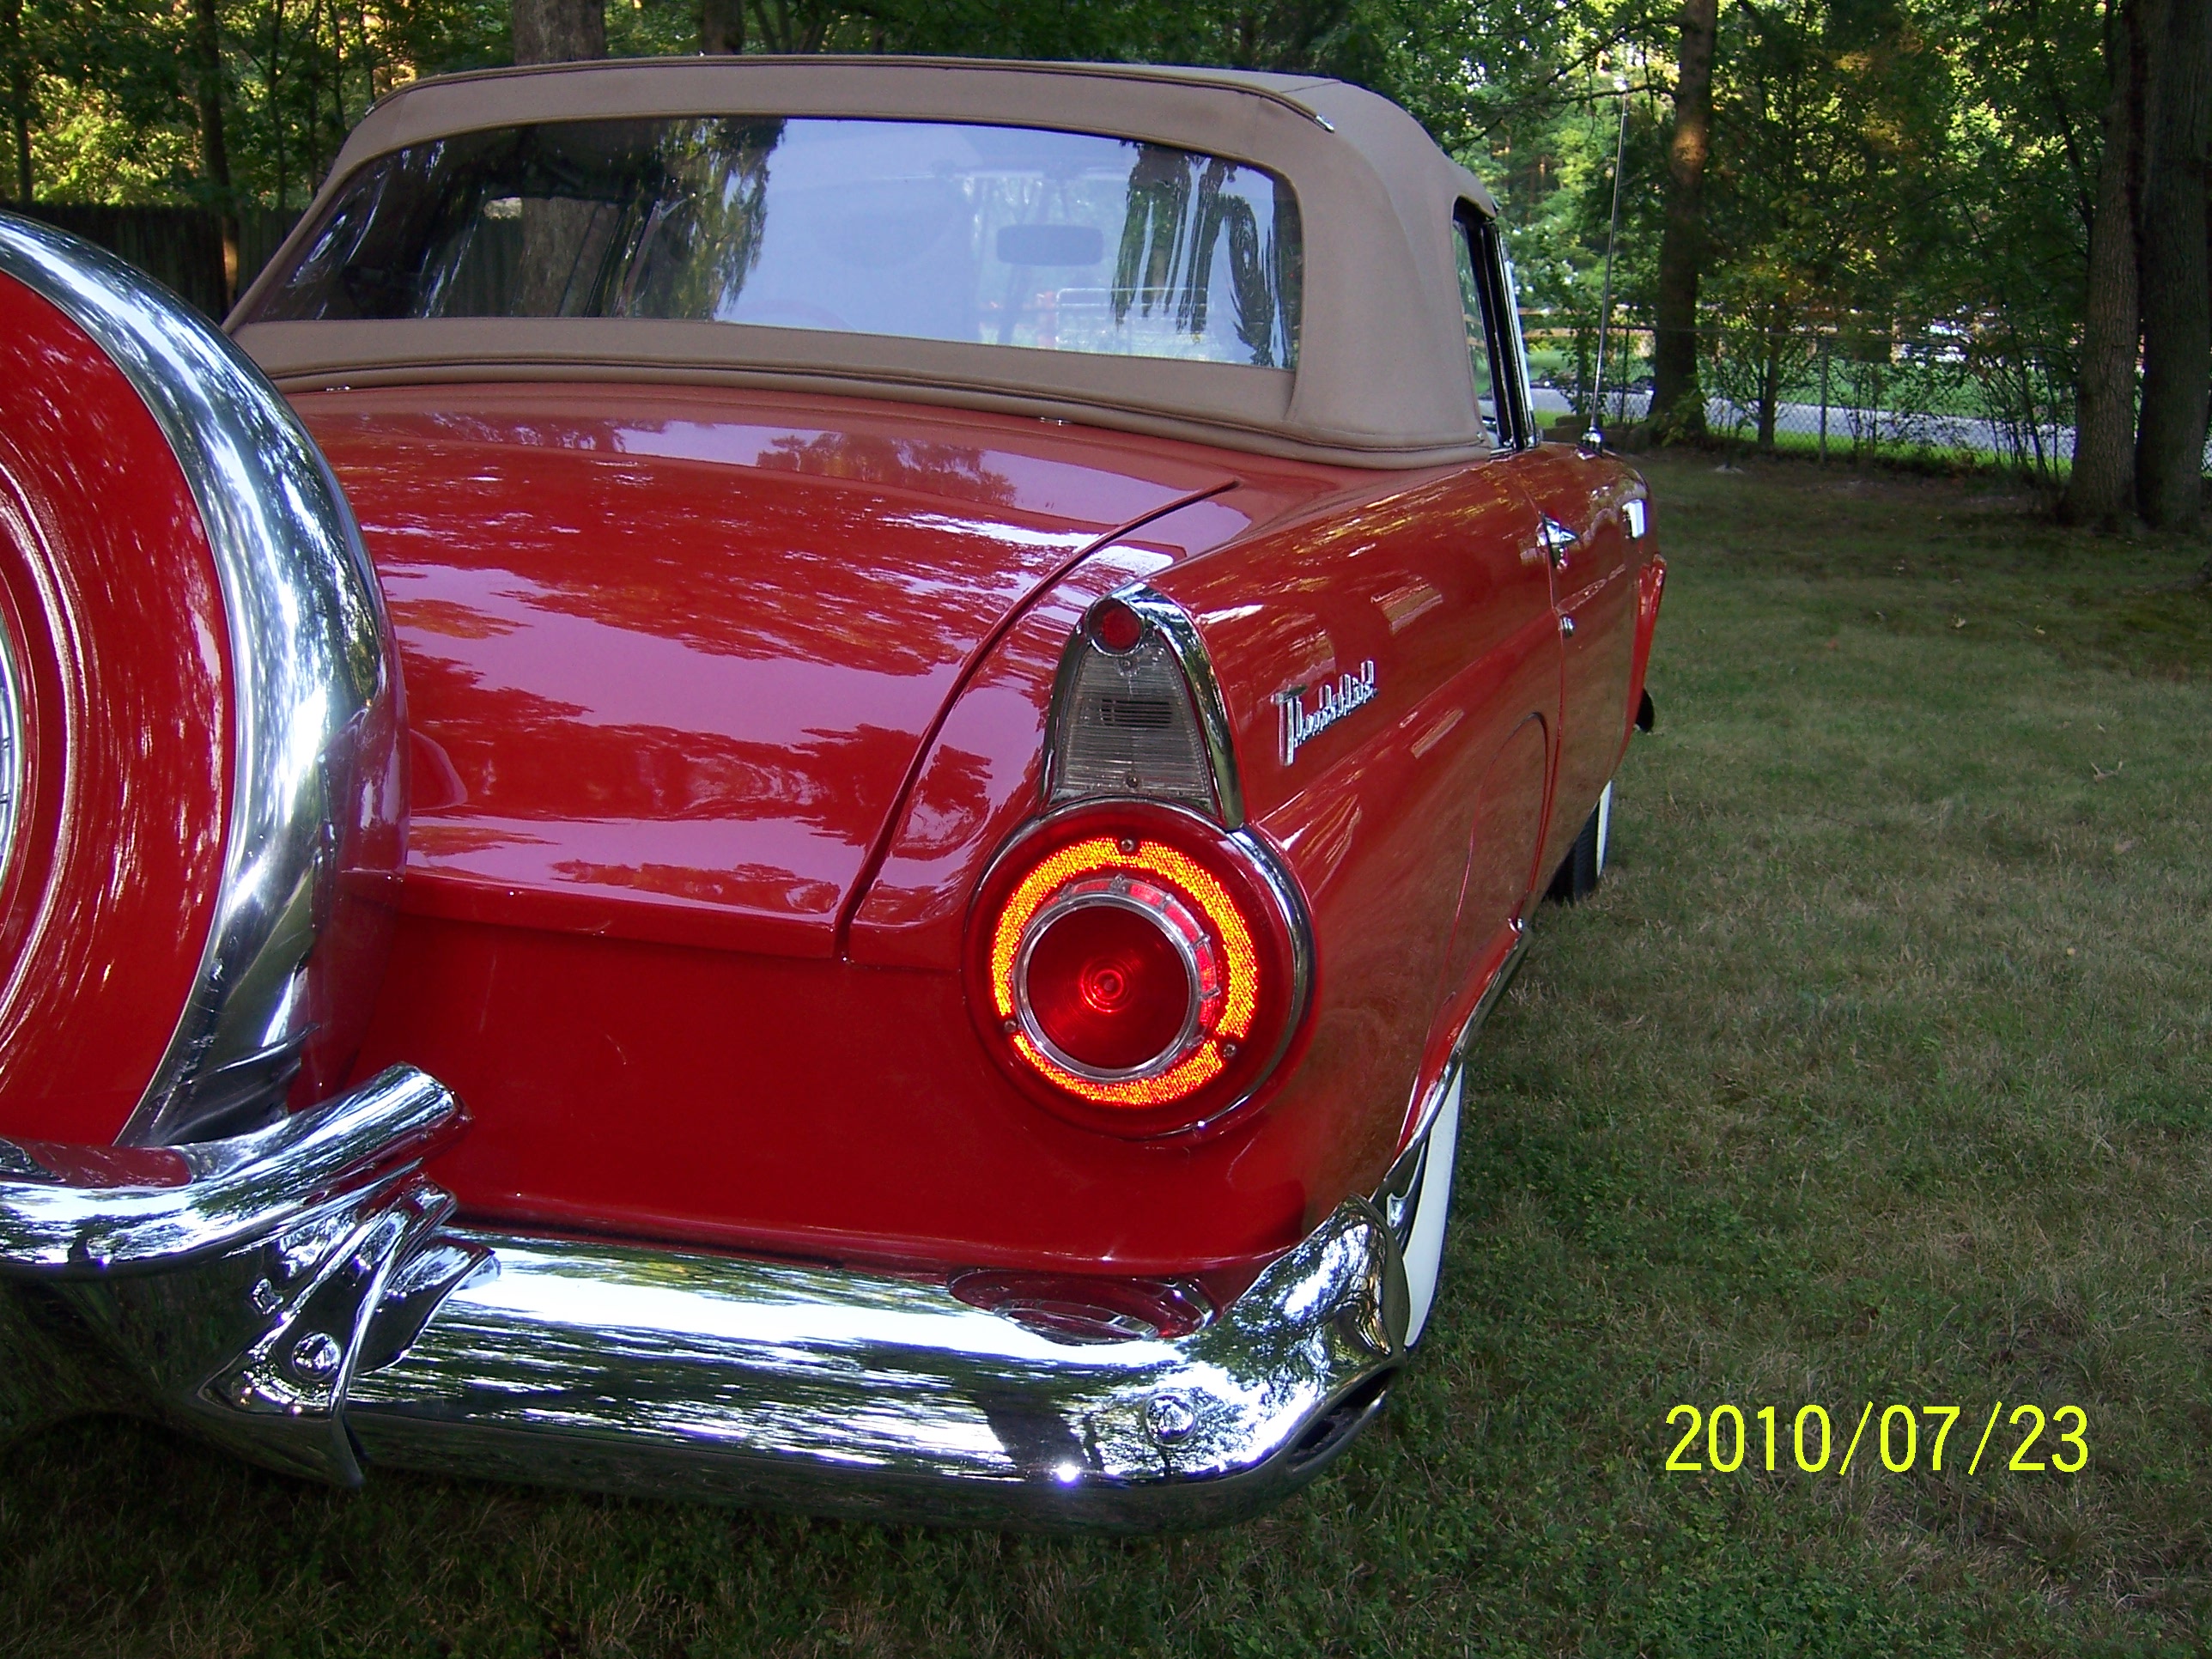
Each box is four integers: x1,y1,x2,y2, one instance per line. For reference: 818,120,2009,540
243,118,1303,369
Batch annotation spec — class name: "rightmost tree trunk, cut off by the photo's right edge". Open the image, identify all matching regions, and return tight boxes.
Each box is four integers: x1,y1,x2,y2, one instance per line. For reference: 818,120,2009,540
2135,0,2212,531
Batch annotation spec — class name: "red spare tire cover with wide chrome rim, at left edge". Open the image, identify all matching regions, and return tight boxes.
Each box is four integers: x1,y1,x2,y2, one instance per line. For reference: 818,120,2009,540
0,215,404,1144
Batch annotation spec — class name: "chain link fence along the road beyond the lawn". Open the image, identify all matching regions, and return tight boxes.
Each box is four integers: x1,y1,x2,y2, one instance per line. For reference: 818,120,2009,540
1528,319,2212,484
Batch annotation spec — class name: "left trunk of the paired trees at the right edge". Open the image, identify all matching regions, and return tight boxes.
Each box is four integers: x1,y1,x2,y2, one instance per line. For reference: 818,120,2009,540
2059,0,2163,529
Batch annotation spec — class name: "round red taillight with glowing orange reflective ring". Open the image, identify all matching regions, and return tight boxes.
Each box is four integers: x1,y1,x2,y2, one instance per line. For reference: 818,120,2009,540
969,801,1310,1134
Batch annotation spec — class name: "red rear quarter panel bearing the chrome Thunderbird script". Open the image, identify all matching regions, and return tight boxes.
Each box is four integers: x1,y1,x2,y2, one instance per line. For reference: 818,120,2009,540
1159,448,1559,1185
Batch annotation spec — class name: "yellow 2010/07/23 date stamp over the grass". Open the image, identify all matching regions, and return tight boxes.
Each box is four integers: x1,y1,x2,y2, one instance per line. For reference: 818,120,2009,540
1666,1401,2088,1475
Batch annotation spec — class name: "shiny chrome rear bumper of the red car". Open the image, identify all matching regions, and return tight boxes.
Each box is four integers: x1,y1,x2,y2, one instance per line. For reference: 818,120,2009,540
0,1068,1409,1531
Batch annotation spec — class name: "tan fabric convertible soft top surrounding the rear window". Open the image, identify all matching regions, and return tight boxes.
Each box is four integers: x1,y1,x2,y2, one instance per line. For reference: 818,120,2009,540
232,58,1495,467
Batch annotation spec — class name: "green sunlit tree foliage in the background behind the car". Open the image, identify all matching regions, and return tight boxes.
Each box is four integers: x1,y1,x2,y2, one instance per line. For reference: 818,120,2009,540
0,0,2104,442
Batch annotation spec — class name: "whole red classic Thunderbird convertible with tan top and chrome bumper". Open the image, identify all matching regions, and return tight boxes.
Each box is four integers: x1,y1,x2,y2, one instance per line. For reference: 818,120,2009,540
0,60,1663,1528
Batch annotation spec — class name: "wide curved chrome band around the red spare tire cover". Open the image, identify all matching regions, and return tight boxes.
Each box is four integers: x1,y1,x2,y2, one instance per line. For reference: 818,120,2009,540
0,212,404,1146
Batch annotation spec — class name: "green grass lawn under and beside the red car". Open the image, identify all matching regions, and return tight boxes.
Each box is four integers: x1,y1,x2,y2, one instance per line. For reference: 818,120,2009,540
0,458,2212,1656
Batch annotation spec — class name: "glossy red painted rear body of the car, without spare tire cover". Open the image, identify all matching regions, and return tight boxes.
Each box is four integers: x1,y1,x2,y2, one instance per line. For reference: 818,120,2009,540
301,387,1655,1281
